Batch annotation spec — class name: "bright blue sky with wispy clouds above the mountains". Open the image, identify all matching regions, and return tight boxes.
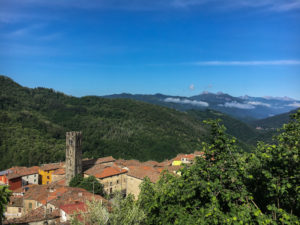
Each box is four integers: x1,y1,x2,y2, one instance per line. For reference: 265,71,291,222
0,0,300,99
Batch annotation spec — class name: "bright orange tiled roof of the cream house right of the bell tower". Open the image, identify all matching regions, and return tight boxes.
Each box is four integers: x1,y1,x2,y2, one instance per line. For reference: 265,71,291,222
84,164,127,179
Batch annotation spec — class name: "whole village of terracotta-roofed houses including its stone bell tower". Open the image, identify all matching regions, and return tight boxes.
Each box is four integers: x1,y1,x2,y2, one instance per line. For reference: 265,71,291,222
0,132,203,225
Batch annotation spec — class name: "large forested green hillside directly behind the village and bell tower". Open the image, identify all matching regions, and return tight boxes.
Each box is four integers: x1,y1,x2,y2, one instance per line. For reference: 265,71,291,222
0,76,207,169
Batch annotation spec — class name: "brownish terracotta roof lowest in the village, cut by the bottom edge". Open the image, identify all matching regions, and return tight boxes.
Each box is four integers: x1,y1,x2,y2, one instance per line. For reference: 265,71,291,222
4,206,60,224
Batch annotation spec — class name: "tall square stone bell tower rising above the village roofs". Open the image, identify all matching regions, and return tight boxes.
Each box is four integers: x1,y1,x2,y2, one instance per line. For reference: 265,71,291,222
66,131,82,186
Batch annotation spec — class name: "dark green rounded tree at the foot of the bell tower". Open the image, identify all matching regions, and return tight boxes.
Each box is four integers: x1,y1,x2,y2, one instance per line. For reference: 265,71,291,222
69,175,104,196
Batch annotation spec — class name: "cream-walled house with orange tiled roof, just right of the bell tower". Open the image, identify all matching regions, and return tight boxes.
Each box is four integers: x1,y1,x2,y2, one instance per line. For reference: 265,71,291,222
84,164,127,194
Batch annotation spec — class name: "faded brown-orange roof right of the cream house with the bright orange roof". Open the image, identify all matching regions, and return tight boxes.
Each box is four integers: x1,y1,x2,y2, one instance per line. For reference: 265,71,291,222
127,166,160,183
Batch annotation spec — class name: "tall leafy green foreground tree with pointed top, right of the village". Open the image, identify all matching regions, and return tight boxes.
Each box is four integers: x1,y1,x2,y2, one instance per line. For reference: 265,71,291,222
139,121,271,224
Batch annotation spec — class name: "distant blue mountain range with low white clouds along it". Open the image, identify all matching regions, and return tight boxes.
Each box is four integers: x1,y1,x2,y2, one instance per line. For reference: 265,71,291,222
102,92,300,122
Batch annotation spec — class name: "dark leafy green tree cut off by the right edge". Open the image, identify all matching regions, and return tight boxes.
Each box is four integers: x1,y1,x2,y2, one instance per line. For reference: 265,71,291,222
248,110,300,224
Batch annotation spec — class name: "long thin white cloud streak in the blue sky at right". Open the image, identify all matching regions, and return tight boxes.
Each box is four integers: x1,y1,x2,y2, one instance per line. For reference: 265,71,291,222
192,60,300,66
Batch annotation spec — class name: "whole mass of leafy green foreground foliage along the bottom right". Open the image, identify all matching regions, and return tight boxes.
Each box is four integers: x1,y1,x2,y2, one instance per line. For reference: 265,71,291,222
72,111,300,225
